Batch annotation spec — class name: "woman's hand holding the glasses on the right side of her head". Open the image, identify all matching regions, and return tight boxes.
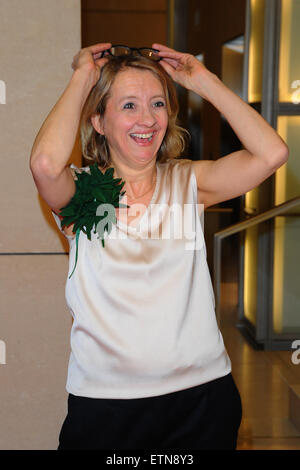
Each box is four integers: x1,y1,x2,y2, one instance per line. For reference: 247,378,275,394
152,43,210,98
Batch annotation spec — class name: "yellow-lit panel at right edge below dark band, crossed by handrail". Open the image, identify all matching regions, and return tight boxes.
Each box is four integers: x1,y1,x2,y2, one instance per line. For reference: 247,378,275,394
273,116,300,334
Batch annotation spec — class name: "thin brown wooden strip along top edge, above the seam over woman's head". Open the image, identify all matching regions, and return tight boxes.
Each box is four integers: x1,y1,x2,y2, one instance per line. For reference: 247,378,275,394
81,0,168,12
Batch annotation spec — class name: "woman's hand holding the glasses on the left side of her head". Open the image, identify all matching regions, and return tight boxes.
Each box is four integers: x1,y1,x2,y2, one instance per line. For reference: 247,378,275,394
72,42,111,85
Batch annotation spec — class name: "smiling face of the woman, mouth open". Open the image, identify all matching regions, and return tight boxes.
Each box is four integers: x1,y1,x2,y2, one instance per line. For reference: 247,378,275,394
100,68,168,168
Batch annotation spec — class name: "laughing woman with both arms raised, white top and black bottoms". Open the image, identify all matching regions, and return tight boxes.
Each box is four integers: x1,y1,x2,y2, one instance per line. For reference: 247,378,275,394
30,43,288,450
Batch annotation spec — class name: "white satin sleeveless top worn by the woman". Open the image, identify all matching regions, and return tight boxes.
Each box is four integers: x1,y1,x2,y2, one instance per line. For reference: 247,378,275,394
52,159,231,398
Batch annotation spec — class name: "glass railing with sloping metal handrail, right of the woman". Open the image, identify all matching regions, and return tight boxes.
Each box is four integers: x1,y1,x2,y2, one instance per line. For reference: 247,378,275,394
213,196,300,349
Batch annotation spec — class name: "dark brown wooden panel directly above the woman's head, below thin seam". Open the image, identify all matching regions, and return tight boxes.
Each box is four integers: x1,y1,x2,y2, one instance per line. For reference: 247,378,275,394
82,11,167,47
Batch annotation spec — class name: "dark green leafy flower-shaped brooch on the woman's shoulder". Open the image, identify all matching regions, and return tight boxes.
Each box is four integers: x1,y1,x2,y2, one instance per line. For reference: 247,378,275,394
59,163,129,279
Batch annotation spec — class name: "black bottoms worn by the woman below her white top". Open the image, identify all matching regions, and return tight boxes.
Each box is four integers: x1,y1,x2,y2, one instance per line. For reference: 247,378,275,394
58,374,242,450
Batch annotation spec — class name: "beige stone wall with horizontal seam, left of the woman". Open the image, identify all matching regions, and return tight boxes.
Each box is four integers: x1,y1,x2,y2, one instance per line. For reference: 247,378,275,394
0,0,81,449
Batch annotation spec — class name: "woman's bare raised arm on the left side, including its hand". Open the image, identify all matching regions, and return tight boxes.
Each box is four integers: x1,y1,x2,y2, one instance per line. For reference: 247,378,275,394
30,43,111,212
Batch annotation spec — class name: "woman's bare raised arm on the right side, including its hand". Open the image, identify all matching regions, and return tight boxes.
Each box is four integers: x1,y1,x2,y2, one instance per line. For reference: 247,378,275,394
153,44,288,208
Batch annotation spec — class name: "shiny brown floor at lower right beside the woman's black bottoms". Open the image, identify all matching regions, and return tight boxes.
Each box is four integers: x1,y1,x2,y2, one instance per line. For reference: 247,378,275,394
220,282,300,450
